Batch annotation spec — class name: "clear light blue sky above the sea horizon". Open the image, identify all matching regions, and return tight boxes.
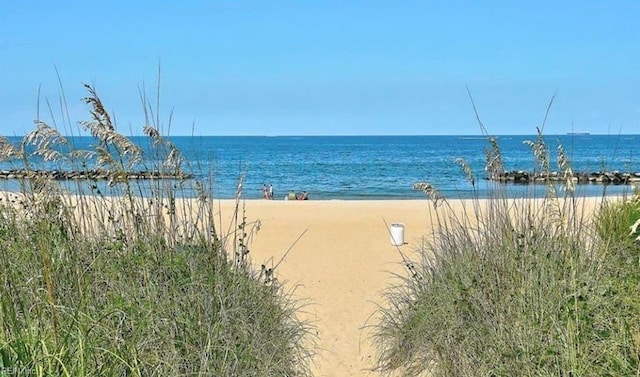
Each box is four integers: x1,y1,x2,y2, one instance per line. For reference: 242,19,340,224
0,0,640,135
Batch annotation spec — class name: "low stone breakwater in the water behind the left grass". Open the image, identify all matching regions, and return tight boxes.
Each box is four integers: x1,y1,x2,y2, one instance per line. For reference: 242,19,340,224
0,169,193,181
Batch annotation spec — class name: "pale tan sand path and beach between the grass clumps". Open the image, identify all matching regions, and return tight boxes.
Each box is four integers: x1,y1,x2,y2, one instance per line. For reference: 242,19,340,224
212,200,452,376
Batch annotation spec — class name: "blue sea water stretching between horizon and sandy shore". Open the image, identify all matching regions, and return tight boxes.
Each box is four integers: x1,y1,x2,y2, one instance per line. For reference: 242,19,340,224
0,135,640,200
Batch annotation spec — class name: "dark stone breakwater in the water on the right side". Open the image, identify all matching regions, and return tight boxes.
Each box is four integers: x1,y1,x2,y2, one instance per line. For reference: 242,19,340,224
487,170,640,185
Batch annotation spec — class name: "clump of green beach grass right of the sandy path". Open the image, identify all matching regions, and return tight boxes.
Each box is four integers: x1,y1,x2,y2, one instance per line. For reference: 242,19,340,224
373,128,640,376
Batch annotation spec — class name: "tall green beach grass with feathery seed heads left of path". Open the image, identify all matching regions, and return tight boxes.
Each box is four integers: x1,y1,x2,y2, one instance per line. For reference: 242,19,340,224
0,85,313,376
